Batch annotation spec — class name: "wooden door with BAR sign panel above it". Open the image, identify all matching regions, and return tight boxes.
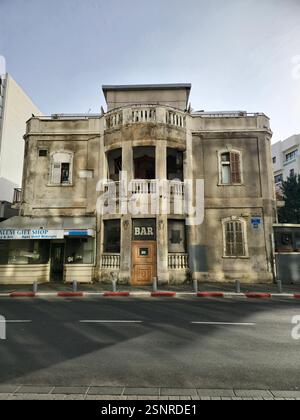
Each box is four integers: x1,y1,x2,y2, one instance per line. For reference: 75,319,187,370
131,219,157,286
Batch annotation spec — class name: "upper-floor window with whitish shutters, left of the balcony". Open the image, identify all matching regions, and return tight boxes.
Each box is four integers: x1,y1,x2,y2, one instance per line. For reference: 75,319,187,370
50,152,73,185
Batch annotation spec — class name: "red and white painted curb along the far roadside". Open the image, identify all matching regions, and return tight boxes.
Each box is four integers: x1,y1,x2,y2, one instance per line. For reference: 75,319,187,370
0,291,300,300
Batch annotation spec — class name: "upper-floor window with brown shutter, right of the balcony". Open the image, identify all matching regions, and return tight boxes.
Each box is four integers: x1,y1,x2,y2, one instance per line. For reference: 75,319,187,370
220,151,242,185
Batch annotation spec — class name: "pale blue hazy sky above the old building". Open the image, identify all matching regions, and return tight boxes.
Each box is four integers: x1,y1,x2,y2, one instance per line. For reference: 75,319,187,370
0,0,300,142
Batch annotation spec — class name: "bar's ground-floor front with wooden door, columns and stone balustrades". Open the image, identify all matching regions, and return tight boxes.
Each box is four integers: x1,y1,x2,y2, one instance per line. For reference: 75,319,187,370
99,217,190,286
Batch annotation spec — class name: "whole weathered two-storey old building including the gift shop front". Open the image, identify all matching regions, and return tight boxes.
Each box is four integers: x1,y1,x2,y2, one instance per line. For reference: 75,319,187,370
0,84,276,285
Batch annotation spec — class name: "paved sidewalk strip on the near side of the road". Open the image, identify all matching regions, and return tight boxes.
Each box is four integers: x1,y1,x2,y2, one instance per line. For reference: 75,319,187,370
0,385,300,401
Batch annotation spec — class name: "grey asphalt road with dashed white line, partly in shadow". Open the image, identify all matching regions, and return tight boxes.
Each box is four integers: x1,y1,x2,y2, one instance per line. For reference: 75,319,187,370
0,297,300,390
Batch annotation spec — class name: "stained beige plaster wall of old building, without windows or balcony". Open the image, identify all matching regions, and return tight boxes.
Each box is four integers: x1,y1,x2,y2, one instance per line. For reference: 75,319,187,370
21,98,275,283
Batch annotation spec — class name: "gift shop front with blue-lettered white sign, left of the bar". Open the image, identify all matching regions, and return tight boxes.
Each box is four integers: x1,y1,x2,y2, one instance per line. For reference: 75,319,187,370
0,217,96,284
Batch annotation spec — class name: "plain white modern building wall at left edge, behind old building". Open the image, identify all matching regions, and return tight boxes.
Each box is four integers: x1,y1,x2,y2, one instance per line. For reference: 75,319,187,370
0,74,41,207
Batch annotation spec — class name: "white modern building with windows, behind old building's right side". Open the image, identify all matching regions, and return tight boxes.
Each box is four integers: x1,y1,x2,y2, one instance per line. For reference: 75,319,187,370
272,134,300,188
